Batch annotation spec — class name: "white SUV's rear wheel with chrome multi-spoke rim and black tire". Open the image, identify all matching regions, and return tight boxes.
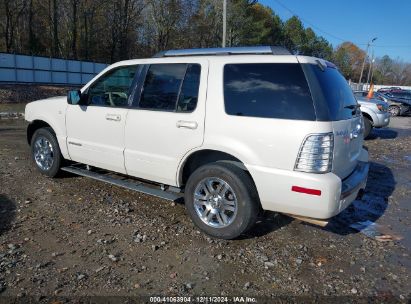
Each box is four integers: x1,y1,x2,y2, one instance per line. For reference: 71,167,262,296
184,162,260,239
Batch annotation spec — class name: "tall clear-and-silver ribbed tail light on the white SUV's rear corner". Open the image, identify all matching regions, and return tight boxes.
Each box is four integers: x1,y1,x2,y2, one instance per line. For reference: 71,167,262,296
294,133,334,173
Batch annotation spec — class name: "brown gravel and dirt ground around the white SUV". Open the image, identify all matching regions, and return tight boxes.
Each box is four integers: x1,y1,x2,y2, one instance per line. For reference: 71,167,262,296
0,108,411,303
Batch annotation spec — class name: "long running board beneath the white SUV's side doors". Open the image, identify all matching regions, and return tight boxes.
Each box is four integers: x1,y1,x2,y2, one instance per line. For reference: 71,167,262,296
61,166,183,201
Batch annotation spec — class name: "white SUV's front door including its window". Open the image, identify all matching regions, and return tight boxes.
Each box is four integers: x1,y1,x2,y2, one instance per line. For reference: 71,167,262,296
66,65,137,173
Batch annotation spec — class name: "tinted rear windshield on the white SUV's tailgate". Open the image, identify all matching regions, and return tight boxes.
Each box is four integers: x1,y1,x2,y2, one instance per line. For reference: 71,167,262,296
302,64,361,121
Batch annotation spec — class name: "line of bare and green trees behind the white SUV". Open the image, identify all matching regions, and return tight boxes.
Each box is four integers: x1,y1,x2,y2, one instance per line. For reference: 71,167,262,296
0,0,411,85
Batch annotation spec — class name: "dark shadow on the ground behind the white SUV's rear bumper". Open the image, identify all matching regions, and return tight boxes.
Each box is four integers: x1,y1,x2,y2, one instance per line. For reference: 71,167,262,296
324,162,396,235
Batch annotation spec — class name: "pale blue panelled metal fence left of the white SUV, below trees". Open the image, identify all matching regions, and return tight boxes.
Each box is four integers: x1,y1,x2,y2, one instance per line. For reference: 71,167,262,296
0,53,107,85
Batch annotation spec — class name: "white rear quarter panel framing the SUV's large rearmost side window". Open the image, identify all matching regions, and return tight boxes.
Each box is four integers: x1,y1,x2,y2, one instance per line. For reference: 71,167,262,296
202,56,333,210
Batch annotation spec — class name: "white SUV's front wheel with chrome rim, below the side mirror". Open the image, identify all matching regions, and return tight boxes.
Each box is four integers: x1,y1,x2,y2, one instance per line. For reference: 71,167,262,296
31,128,63,177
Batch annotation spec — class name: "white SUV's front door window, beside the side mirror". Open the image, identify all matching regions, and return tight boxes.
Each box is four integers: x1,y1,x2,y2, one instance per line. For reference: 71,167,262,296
87,65,137,107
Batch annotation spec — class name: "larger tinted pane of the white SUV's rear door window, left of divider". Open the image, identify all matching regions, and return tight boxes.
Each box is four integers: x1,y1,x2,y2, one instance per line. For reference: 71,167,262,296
139,63,187,111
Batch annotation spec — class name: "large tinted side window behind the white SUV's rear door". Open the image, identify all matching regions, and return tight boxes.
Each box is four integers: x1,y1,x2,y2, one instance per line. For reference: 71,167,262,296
224,63,315,120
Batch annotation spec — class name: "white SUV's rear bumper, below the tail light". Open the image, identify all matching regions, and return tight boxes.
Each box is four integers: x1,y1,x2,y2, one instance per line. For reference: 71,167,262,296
247,149,369,219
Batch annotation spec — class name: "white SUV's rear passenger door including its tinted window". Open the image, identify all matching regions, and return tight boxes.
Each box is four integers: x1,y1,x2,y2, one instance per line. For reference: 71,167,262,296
124,59,208,185
